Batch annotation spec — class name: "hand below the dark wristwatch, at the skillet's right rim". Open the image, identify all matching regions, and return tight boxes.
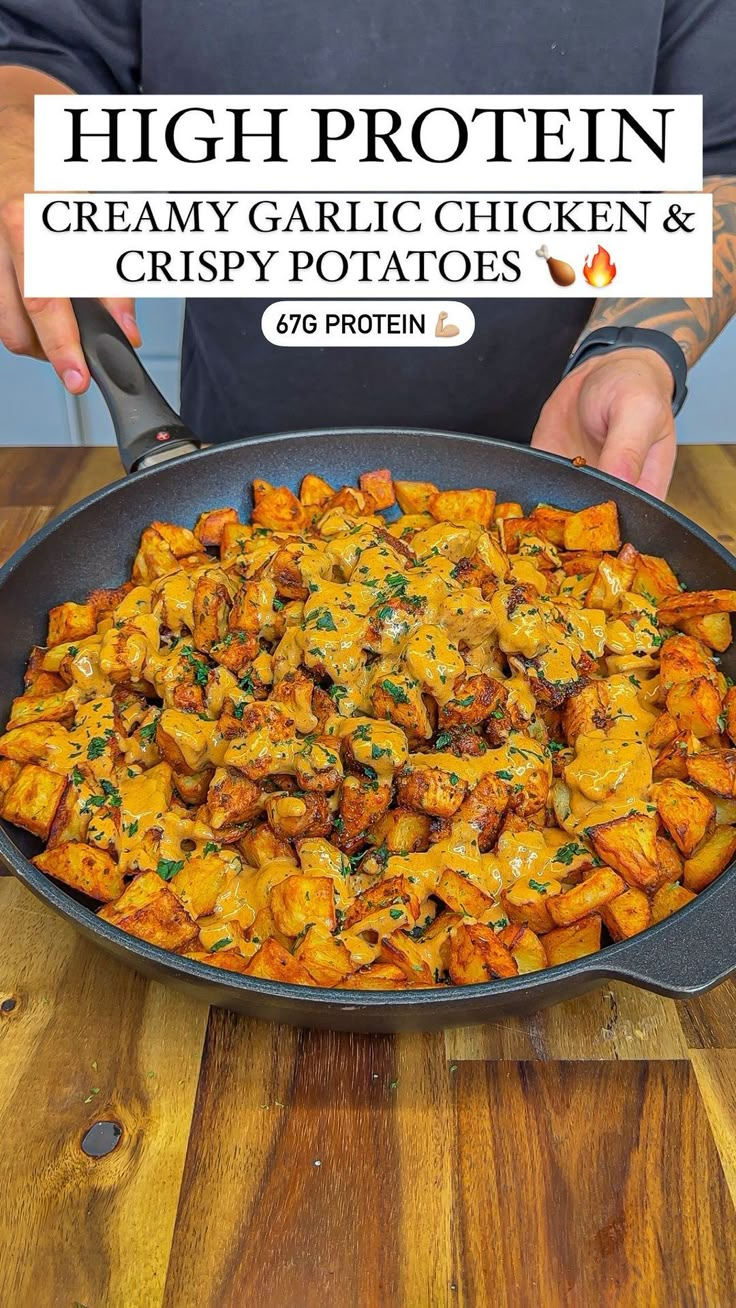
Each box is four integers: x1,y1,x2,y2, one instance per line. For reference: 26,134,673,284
532,349,676,500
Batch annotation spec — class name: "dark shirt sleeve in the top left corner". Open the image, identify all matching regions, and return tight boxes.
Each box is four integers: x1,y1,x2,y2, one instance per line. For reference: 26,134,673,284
0,0,140,95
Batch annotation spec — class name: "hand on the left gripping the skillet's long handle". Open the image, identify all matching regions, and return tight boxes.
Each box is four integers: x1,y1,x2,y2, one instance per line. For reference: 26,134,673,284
0,96,141,395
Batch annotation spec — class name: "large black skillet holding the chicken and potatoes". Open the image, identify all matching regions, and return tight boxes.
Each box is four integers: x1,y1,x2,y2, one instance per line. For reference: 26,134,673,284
0,301,736,1031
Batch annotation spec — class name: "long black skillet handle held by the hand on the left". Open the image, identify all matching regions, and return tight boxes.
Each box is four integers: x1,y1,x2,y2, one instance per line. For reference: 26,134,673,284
72,298,201,472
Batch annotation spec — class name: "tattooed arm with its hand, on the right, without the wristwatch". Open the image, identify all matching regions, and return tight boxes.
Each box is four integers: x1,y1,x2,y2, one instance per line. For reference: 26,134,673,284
532,177,736,498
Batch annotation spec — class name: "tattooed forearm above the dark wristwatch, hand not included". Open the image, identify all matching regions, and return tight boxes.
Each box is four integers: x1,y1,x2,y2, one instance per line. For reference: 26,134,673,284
580,177,736,366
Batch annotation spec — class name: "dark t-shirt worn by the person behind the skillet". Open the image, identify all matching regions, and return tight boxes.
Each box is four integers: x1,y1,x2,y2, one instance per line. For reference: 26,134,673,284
0,0,736,442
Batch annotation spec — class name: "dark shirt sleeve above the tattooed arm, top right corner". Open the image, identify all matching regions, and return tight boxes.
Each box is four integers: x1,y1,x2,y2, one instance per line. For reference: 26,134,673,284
655,0,736,177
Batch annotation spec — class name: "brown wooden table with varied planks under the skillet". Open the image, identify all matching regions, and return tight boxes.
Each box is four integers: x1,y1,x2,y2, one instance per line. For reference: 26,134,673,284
0,446,736,1308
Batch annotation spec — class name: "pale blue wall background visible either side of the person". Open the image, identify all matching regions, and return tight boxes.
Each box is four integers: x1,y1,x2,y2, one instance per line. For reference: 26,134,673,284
0,300,736,446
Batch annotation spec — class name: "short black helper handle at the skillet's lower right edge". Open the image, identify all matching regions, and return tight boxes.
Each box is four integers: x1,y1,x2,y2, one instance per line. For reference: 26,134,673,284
591,867,736,999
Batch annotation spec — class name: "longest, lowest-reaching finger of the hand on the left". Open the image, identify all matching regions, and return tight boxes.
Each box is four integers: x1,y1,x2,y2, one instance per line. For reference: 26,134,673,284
3,200,90,395
